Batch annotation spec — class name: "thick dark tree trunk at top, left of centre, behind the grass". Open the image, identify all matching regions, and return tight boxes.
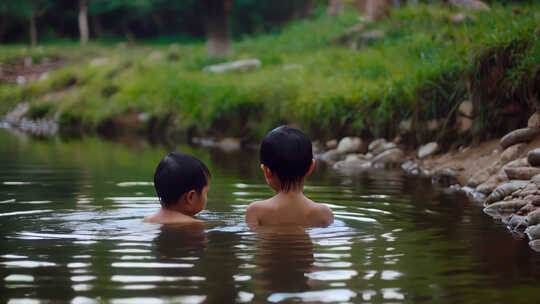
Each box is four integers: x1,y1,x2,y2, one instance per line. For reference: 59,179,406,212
206,0,232,57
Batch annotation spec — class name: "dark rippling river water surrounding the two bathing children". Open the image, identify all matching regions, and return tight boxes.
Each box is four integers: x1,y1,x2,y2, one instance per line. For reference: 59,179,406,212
0,129,540,303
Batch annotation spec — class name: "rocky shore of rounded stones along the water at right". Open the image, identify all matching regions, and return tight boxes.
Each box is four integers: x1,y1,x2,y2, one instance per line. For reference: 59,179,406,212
316,112,540,251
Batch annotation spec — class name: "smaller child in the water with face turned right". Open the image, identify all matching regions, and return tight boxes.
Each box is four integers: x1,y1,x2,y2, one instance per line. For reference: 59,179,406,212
144,152,210,224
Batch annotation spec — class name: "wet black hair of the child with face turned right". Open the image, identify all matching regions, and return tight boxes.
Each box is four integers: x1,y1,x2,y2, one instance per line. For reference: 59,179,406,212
154,152,211,207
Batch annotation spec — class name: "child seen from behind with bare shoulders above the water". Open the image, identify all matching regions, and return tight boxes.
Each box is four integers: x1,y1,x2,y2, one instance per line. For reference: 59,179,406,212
246,126,334,230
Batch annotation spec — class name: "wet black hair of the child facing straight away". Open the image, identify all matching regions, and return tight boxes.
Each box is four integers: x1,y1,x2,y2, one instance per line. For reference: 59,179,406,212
260,126,313,192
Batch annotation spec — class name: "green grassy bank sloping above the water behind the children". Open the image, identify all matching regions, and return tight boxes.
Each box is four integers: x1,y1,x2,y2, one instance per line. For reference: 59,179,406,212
0,5,540,142
